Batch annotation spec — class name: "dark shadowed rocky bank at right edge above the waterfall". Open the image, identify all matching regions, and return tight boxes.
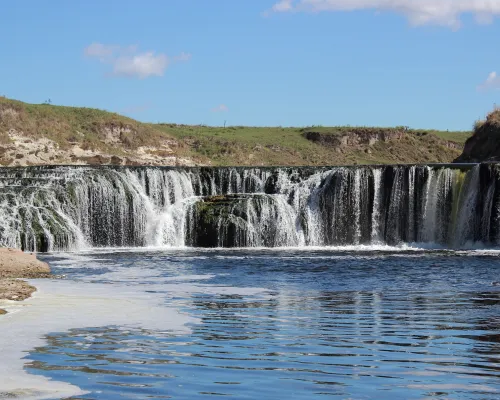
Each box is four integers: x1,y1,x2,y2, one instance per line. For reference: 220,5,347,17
454,114,500,163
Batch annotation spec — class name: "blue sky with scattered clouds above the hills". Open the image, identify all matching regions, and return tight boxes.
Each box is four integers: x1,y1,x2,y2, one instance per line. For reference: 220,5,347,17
0,0,500,130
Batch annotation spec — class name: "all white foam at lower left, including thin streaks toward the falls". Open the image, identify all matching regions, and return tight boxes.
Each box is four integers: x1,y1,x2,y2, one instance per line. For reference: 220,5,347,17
0,254,270,399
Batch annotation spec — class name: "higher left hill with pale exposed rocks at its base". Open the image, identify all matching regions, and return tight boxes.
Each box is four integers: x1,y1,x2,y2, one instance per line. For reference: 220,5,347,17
0,98,193,165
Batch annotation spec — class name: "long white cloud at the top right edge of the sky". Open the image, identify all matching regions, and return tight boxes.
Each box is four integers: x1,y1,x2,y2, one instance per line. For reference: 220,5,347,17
272,0,500,29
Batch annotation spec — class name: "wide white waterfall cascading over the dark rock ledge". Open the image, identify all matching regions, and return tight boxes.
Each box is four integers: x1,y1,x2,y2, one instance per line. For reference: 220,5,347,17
0,164,500,251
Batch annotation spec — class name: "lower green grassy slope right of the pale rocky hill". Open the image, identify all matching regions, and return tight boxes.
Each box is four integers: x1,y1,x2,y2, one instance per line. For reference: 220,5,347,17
154,124,471,165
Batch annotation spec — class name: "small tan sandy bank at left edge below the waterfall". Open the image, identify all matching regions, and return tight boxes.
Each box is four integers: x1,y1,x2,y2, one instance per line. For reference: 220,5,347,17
0,248,50,315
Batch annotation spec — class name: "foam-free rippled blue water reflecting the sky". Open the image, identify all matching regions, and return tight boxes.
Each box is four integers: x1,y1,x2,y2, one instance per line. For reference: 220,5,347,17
29,255,500,400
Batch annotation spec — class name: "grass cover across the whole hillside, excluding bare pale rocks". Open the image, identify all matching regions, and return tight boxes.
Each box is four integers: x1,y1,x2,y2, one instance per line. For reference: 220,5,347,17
0,98,471,166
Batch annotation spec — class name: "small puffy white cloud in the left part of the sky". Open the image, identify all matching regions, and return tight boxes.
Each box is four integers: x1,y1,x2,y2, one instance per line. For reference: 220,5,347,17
84,43,191,79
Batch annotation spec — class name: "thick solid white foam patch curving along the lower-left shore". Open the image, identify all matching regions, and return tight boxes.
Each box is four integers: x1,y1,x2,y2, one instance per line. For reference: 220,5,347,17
0,280,199,399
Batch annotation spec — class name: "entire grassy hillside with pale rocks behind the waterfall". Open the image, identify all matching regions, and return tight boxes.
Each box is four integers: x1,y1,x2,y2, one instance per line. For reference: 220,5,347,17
0,98,471,166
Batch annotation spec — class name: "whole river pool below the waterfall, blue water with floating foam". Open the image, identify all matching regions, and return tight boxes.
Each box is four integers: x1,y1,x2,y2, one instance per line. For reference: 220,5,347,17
4,247,500,400
